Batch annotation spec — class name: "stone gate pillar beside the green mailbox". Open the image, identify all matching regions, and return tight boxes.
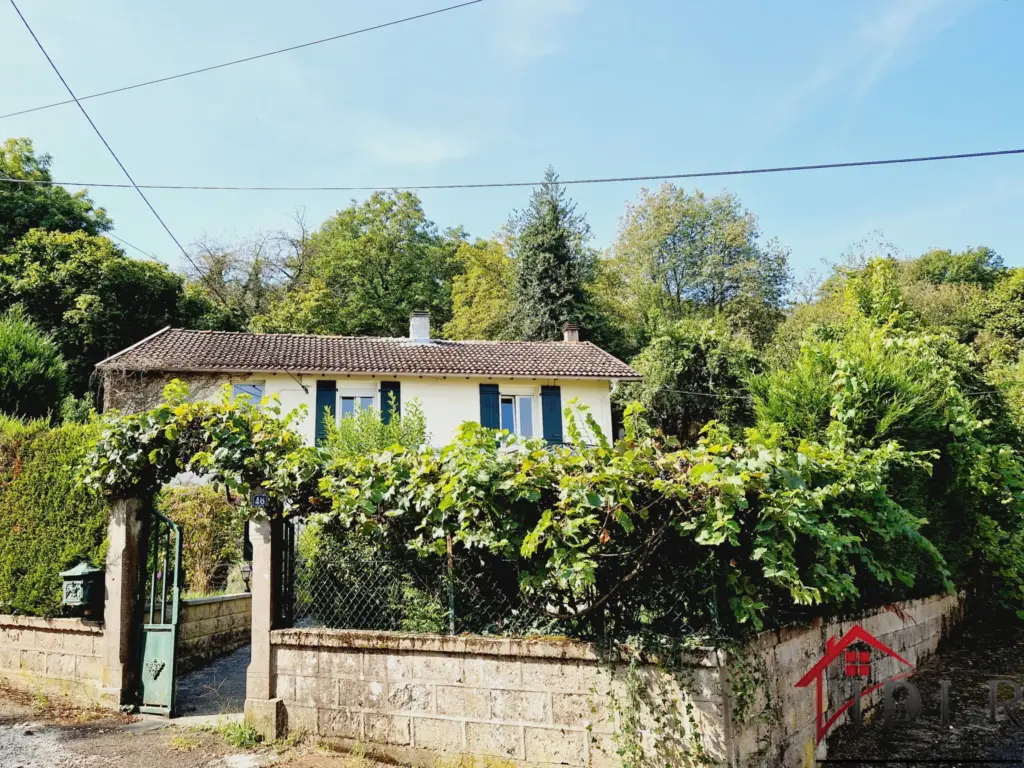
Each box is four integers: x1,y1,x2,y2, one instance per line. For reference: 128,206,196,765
102,499,145,705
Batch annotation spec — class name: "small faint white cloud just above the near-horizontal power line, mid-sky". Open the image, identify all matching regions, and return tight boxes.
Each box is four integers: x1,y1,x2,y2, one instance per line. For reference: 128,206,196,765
353,116,472,166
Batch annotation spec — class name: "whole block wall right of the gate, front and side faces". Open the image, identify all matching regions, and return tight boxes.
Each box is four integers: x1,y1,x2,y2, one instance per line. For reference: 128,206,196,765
260,596,963,767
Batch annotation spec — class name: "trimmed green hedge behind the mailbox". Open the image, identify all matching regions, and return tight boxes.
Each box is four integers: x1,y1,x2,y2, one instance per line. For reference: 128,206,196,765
0,417,109,616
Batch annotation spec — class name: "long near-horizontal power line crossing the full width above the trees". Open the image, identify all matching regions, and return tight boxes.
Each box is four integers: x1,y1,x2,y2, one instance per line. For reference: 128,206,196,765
0,148,1024,193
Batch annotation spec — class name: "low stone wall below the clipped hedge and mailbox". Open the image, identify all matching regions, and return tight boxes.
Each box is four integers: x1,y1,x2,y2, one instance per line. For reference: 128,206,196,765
0,615,107,706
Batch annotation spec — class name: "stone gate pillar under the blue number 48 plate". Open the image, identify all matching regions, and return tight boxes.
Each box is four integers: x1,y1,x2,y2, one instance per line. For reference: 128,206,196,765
246,518,285,741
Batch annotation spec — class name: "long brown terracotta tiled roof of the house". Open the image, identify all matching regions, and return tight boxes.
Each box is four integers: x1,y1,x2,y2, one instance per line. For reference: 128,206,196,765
96,328,639,379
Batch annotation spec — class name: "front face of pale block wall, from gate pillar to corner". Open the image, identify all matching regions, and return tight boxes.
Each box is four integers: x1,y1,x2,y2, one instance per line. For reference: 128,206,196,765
271,630,726,766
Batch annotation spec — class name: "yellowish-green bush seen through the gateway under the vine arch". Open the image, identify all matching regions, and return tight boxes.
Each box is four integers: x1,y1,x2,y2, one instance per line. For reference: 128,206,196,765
157,485,246,595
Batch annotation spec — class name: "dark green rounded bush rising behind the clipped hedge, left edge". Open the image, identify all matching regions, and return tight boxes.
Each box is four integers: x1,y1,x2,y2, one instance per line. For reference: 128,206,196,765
0,306,68,419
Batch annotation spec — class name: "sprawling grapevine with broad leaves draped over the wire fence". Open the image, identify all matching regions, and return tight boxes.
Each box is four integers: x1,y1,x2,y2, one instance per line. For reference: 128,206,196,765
321,406,945,636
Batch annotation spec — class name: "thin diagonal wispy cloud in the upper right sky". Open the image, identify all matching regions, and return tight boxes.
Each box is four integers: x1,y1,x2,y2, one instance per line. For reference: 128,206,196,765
773,0,974,128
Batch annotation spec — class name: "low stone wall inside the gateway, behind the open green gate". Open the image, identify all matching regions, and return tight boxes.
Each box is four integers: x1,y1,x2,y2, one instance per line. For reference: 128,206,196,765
177,594,252,674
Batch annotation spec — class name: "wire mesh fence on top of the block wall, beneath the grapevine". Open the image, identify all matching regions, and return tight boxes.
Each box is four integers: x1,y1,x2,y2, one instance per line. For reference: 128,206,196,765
281,520,718,639
